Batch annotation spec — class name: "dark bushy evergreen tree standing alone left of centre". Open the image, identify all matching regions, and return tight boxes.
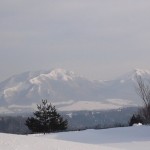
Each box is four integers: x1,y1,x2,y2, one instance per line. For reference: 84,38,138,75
26,100,68,134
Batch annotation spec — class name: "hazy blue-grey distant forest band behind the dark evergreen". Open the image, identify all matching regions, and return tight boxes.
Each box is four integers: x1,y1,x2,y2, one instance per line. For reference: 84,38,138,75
0,107,137,134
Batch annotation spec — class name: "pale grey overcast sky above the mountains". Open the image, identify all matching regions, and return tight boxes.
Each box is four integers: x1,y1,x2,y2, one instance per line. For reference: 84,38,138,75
0,0,150,81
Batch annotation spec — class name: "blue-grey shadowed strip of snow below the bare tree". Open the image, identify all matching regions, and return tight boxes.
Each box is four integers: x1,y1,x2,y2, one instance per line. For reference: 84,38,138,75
41,126,150,144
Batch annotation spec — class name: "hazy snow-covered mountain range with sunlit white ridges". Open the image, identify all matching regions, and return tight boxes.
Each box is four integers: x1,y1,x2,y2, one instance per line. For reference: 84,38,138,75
0,69,150,112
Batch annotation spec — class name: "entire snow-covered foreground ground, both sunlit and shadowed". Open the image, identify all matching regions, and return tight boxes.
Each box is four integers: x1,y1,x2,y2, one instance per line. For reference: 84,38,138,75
0,126,150,150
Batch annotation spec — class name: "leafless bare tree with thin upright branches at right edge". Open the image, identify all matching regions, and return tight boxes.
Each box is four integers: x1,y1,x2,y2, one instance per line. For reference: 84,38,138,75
136,76,150,123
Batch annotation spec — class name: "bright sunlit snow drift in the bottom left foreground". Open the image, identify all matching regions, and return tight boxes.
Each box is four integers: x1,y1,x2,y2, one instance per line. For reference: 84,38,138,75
0,133,117,150
